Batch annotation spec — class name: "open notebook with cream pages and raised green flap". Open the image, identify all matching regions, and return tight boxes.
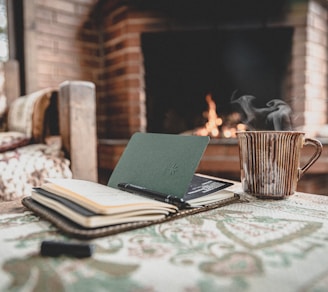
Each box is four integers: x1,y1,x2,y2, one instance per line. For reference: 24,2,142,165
23,133,239,237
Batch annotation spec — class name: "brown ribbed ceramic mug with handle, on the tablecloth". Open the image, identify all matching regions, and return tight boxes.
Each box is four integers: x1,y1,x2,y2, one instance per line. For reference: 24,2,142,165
237,131,322,199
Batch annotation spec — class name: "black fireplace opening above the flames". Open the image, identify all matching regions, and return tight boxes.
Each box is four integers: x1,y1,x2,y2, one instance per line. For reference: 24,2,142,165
141,27,293,133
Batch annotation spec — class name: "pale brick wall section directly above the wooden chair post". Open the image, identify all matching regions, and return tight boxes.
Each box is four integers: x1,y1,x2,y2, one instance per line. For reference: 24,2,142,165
23,0,107,135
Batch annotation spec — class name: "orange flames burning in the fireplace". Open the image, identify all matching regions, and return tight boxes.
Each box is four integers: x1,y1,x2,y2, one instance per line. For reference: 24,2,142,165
195,93,246,138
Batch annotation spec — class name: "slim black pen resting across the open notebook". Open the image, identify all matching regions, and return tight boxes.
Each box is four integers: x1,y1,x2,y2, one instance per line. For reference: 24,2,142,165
117,183,190,209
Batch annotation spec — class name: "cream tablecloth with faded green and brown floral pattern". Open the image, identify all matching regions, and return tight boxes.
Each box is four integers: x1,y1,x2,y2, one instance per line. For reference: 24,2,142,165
0,185,328,292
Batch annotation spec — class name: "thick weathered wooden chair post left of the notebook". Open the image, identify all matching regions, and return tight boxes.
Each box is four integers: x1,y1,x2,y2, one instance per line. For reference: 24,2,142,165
59,81,98,182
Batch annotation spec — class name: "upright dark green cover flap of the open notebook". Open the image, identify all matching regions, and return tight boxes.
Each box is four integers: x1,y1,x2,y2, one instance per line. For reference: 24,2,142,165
108,133,210,198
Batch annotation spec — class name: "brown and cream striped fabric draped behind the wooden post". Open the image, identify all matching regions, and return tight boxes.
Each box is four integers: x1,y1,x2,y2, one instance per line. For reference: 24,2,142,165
8,88,56,143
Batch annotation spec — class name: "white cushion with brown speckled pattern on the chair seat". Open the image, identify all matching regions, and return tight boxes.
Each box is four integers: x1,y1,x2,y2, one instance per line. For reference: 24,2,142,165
0,144,72,201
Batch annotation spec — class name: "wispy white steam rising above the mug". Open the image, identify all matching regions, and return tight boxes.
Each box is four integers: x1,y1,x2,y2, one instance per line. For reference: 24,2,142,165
231,91,293,131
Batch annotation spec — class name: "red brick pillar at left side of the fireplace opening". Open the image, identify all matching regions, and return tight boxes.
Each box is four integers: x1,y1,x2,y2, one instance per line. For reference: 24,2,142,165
97,2,167,138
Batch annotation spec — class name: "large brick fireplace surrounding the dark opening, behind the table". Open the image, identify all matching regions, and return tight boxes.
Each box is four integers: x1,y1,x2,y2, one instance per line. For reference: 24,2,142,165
96,0,328,196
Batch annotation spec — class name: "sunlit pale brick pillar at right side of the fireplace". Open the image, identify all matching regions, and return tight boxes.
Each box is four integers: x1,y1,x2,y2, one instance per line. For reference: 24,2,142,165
287,1,328,136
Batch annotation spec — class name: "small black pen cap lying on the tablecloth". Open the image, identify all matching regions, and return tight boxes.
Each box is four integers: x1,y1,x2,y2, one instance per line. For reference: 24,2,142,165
40,240,93,258
